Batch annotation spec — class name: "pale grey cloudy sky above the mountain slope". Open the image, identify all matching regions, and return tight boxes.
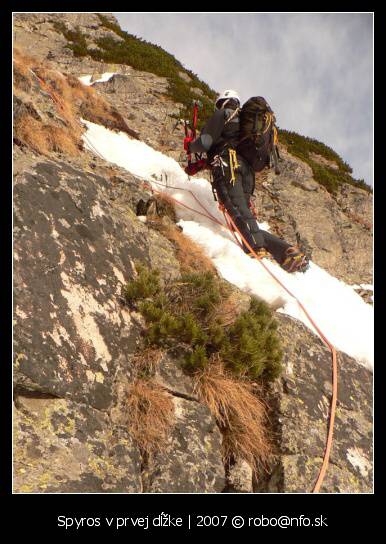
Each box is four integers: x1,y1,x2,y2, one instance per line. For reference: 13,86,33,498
114,13,373,185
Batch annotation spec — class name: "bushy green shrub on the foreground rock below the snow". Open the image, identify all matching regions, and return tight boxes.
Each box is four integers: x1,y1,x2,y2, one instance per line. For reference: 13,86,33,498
125,268,282,381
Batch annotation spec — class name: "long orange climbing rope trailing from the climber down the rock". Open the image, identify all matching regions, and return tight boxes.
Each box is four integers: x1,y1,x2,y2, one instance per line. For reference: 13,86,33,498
31,70,338,493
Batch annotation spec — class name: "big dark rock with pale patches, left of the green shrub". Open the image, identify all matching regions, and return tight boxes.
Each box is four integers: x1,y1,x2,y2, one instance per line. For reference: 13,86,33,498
14,157,179,409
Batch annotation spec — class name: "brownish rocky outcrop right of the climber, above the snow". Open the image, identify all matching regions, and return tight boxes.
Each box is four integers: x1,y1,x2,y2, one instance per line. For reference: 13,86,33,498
256,149,372,283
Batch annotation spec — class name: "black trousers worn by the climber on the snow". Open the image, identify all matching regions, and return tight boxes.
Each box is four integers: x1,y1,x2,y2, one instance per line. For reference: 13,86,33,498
212,152,290,264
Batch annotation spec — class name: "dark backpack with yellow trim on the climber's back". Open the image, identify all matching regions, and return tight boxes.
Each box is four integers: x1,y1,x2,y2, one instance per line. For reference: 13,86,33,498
236,96,280,174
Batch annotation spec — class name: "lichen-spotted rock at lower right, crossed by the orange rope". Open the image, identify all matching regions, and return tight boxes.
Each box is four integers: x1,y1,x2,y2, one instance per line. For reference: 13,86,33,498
256,315,372,493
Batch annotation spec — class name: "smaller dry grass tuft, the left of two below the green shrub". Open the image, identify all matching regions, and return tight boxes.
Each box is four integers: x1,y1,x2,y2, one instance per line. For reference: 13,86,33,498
127,380,174,455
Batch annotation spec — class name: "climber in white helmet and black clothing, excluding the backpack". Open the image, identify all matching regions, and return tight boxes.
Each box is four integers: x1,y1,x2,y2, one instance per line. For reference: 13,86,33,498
184,90,308,272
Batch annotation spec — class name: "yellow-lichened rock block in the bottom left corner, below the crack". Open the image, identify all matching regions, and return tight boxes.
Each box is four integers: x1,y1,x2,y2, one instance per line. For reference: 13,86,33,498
14,396,142,493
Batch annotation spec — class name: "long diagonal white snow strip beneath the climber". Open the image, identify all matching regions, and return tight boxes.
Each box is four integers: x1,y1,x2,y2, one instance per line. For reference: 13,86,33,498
83,121,373,369
